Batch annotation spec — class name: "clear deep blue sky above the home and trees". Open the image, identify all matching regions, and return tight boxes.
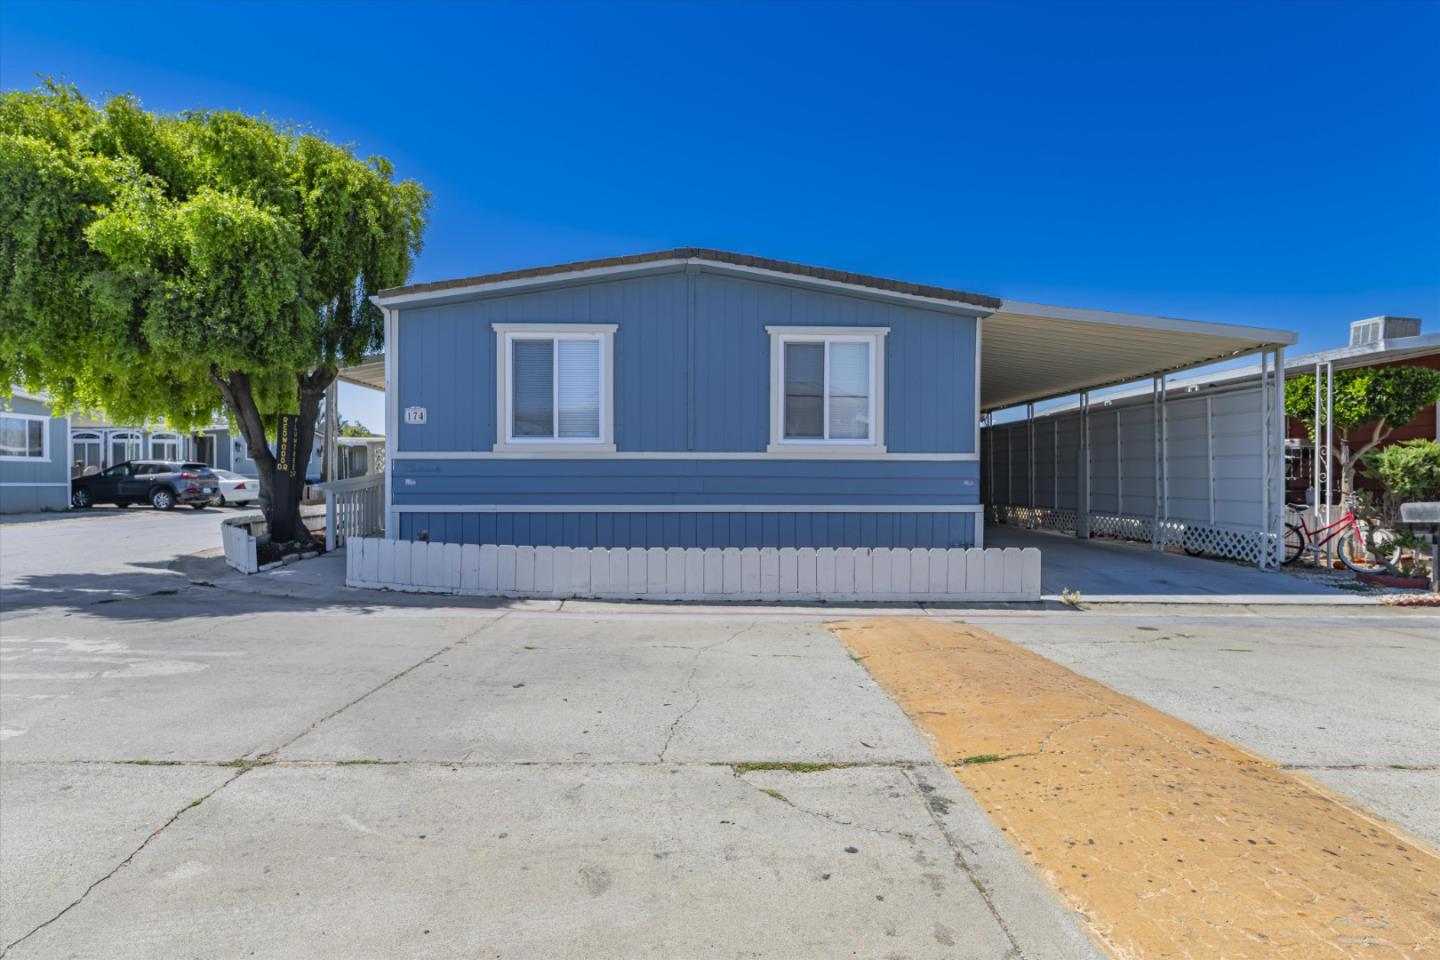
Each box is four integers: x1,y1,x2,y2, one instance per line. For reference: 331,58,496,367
0,0,1440,427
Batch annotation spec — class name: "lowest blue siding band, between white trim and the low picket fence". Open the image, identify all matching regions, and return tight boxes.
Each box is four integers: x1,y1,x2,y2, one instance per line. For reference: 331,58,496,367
399,511,975,547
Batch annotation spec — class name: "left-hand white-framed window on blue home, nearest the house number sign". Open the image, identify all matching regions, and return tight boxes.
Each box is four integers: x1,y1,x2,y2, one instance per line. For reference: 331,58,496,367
494,324,615,453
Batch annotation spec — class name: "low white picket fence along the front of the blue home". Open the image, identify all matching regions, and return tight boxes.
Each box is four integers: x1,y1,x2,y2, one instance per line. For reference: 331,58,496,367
346,537,1040,602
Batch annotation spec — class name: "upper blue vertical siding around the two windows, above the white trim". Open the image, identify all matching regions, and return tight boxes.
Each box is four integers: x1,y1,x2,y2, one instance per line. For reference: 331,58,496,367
392,271,976,453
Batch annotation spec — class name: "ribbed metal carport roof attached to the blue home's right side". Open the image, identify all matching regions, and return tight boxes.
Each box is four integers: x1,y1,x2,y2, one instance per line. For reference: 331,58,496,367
981,301,1295,412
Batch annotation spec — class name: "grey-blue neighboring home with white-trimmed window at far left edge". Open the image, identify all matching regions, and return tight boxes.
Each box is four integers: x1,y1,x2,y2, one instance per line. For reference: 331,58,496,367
0,390,71,514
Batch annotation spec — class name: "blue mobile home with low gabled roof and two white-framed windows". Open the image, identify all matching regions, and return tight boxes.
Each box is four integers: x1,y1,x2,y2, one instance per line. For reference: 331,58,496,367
374,249,999,547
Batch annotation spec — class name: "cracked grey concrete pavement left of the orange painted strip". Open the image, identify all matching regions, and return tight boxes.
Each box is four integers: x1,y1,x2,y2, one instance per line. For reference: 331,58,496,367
0,587,1094,960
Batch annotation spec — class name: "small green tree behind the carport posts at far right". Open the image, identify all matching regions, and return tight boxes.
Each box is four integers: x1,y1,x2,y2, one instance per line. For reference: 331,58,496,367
1284,367,1440,494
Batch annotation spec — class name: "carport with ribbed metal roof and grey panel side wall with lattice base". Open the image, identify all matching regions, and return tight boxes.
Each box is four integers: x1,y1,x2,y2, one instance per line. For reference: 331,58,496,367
979,301,1295,569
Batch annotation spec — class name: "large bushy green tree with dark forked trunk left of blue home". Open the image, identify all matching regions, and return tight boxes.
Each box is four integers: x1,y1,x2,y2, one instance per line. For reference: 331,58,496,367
0,82,429,530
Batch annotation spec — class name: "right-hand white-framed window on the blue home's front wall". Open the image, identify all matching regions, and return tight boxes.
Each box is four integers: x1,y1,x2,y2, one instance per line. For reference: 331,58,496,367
768,327,887,455
